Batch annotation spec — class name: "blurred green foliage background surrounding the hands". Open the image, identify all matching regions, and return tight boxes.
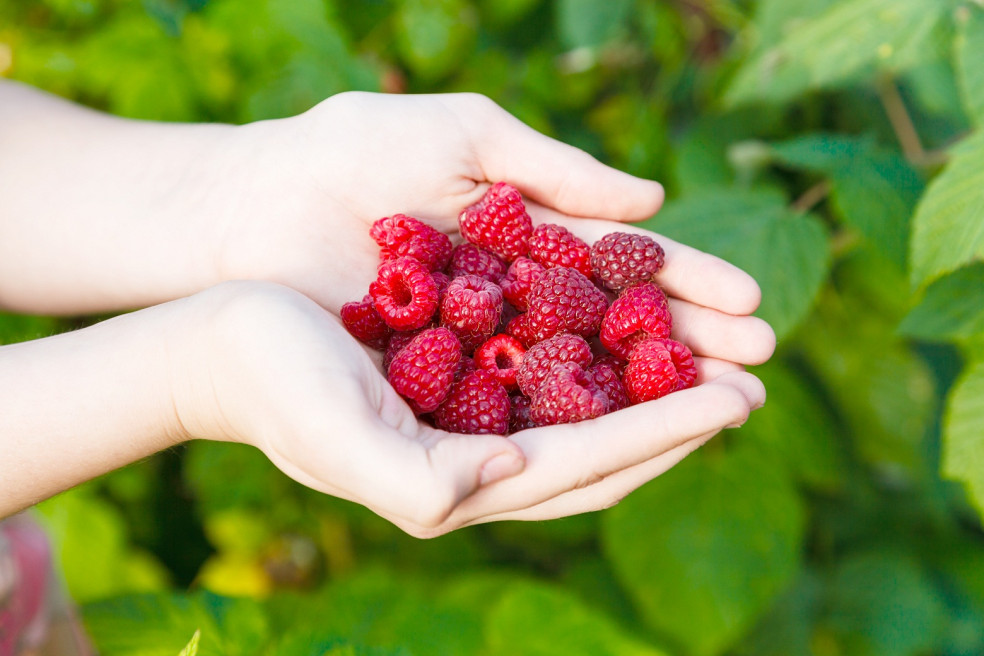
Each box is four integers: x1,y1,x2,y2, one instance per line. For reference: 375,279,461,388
0,0,984,656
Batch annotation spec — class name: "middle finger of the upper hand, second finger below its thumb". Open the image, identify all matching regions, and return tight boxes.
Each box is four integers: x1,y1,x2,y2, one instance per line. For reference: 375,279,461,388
670,298,776,365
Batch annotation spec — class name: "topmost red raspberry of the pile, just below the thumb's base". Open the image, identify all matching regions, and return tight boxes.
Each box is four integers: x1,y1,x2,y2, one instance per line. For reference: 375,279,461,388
458,182,533,262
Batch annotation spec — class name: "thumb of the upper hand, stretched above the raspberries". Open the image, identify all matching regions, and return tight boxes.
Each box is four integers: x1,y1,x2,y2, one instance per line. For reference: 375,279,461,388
449,96,664,221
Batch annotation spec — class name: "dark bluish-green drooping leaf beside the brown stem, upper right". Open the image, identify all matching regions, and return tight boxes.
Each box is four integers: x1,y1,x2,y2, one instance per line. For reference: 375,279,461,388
773,135,923,268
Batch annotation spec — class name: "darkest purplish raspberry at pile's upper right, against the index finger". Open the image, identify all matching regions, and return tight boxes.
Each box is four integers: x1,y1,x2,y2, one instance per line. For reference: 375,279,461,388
590,232,665,291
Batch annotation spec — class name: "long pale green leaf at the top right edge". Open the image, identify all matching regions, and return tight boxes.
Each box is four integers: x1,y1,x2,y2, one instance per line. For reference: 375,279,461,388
725,0,947,105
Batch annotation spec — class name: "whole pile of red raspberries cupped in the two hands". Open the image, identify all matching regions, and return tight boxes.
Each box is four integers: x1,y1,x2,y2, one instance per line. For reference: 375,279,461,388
341,182,697,435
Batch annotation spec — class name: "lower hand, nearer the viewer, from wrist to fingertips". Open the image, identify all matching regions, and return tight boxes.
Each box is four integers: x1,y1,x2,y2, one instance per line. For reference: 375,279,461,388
169,282,765,537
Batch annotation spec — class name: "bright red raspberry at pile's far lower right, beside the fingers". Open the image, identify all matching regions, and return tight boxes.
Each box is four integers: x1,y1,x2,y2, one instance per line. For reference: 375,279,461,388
622,337,697,403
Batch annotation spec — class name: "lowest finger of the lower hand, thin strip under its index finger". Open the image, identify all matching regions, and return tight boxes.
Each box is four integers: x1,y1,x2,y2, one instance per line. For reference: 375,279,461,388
466,431,720,524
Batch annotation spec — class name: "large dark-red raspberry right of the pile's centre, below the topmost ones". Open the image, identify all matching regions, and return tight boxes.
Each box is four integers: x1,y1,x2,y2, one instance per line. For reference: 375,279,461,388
527,267,608,341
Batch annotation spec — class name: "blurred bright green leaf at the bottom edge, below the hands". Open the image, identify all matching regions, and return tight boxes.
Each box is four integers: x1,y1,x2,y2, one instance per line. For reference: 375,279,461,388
485,581,666,656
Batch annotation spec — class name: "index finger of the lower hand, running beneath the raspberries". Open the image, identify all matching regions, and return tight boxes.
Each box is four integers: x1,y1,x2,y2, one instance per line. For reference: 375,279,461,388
451,373,765,523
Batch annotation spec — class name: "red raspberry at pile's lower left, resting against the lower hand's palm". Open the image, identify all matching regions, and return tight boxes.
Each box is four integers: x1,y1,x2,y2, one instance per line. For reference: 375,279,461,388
389,328,461,415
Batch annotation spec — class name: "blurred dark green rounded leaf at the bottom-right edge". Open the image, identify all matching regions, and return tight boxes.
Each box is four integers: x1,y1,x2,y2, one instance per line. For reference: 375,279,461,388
826,551,948,656
